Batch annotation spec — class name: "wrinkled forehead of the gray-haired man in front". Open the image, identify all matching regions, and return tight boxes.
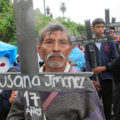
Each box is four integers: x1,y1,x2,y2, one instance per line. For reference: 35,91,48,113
43,30,68,39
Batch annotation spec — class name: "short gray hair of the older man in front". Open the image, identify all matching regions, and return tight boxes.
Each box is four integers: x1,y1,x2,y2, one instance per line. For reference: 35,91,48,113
38,22,72,44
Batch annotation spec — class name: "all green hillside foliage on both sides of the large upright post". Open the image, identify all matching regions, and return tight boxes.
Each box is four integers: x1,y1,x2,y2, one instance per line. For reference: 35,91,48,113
0,0,85,45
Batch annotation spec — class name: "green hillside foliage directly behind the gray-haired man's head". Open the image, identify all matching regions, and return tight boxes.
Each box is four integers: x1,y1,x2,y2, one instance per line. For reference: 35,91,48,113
35,15,86,37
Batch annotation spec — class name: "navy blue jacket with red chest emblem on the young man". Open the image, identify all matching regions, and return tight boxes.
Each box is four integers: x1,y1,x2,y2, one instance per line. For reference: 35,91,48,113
85,42,118,80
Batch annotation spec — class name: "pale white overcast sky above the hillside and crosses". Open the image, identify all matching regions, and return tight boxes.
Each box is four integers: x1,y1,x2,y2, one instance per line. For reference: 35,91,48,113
33,0,120,24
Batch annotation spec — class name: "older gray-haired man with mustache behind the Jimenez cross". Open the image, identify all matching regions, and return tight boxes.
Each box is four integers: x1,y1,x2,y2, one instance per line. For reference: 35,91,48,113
7,23,104,120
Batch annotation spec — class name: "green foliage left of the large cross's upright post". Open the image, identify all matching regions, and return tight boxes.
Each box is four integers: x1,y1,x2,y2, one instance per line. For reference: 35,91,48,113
0,0,16,42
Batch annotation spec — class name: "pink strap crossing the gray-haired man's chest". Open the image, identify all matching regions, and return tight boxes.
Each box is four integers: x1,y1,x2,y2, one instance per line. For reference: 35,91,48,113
43,92,59,111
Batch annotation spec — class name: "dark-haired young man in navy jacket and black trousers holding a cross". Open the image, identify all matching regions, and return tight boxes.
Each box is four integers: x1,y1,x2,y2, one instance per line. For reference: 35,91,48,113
85,18,118,120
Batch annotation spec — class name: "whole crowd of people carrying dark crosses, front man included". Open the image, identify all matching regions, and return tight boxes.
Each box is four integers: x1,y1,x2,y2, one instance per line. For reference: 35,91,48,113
0,18,120,120
